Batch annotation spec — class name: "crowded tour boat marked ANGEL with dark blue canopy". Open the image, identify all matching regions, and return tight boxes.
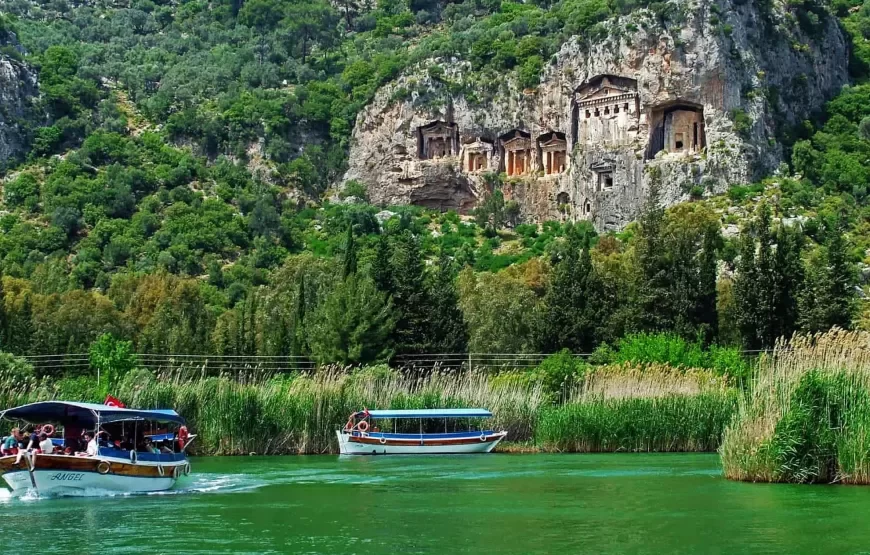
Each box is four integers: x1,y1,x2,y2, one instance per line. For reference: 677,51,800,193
0,401,196,494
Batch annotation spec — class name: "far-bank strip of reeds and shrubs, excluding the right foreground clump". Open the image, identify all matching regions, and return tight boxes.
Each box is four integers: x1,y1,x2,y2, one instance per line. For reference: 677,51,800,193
0,334,747,455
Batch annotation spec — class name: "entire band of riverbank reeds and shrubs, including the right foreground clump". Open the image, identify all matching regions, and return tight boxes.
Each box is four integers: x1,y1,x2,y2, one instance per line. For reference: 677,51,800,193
0,329,870,484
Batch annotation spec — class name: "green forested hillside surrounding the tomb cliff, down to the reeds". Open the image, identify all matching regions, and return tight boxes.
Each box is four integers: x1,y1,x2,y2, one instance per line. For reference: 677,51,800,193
0,0,870,362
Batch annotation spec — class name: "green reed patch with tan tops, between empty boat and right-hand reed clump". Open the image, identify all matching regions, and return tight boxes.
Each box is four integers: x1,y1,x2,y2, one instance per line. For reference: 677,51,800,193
536,364,736,452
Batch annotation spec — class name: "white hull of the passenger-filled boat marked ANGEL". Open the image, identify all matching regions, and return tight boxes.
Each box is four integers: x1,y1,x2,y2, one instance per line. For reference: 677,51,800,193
0,455,189,494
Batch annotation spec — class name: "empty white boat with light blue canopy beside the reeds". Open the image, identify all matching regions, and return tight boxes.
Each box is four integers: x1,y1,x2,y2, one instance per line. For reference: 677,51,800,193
336,409,507,455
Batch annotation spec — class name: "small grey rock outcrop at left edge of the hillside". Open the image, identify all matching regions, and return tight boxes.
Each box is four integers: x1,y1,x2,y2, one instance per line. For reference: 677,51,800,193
0,33,38,167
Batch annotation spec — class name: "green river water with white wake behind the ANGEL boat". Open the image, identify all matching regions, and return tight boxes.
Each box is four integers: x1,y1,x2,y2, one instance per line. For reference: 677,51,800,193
0,454,870,555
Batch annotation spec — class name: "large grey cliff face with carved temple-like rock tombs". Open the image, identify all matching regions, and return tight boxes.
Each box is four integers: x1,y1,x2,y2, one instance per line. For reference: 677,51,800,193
345,0,848,229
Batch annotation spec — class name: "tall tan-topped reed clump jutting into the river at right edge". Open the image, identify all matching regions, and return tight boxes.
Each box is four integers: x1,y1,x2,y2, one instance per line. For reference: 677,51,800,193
720,330,870,484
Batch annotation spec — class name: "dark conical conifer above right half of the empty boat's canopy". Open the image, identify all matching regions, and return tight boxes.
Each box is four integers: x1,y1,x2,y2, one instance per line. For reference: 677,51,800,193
427,252,468,353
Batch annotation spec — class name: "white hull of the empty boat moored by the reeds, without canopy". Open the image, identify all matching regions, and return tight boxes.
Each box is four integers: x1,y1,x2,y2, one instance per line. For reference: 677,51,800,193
336,430,507,455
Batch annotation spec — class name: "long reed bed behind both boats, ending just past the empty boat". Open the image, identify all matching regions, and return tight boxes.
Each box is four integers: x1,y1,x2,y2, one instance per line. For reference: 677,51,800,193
0,367,544,455
